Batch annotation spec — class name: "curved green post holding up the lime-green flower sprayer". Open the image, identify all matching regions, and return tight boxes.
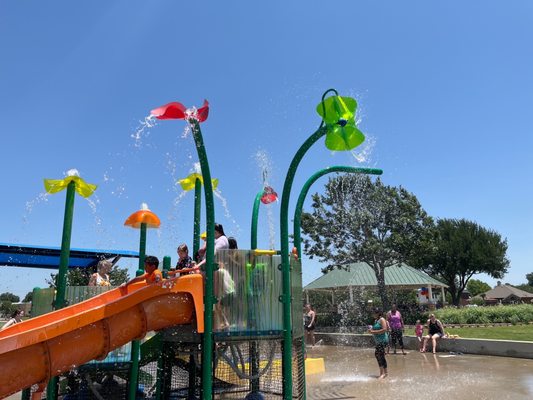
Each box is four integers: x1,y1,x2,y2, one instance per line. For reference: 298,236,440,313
280,124,327,400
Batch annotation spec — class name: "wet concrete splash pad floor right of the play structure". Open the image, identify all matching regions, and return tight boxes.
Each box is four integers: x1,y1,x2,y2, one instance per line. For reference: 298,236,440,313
307,346,533,400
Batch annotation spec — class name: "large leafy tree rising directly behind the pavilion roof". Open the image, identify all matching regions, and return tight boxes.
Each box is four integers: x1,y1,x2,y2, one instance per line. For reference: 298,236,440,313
302,174,432,309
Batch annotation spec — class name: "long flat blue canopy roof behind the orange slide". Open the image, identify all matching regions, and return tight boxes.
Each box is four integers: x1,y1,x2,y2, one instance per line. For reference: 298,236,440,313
0,243,139,269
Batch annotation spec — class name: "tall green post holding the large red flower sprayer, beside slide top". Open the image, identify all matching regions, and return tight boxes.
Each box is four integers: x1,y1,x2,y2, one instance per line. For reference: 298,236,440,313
189,119,215,400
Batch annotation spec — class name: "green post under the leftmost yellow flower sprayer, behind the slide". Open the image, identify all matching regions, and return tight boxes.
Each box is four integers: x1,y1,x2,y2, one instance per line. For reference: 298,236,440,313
46,181,76,400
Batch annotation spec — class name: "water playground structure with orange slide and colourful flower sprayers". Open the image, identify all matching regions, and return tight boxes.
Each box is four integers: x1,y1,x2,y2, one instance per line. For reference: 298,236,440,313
0,89,381,400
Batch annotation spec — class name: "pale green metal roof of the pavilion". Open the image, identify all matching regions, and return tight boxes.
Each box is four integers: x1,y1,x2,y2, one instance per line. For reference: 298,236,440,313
304,263,448,290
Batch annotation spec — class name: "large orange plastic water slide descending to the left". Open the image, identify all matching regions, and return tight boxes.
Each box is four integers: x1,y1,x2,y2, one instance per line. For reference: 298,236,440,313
0,274,204,398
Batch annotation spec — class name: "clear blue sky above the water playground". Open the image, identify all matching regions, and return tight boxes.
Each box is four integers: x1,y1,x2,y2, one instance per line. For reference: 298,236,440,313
0,0,533,296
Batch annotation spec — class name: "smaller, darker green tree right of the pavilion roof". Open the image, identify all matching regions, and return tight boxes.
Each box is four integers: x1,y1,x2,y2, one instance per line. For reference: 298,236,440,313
418,219,509,305
